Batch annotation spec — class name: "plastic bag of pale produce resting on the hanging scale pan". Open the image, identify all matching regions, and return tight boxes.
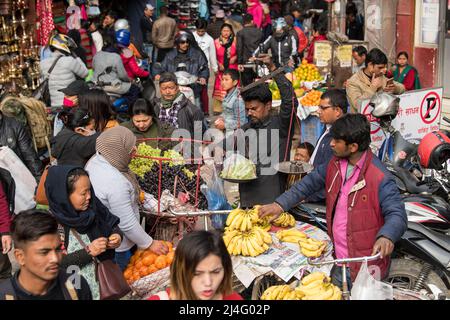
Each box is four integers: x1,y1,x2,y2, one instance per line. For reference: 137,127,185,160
221,153,256,180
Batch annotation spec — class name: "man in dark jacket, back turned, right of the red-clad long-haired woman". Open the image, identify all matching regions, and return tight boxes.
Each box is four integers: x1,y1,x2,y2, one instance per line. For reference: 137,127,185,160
236,14,263,86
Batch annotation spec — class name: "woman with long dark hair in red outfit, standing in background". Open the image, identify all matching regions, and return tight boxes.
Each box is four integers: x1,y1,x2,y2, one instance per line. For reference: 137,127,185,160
213,23,238,113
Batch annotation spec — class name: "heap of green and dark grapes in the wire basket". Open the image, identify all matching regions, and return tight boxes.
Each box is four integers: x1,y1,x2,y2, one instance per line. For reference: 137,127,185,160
129,143,208,209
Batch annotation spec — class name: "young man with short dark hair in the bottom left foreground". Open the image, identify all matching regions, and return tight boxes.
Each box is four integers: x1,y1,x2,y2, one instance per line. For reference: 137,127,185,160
0,210,92,301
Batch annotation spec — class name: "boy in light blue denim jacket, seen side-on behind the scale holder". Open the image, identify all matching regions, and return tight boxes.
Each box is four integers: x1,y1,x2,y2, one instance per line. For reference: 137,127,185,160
214,69,247,131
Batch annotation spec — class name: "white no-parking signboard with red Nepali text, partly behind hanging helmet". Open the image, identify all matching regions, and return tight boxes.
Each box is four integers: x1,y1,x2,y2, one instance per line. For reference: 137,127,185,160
360,88,443,148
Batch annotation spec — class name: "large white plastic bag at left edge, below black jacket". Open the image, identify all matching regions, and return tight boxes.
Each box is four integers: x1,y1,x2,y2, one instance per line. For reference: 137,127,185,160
0,147,37,213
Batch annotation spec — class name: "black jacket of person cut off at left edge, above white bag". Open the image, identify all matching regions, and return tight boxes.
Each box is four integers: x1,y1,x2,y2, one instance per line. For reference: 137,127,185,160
0,112,43,179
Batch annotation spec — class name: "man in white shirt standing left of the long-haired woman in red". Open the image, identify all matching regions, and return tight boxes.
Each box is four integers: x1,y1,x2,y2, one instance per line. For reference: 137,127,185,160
193,19,218,114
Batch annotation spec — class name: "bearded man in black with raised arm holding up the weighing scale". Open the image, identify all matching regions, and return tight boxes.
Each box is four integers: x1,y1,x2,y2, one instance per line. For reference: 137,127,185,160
230,54,298,208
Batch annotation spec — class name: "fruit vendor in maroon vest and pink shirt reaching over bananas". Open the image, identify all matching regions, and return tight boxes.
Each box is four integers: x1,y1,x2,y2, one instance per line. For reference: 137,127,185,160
260,114,407,287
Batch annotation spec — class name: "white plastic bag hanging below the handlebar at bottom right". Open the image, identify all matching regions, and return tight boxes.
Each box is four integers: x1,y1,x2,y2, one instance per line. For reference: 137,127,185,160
351,261,394,300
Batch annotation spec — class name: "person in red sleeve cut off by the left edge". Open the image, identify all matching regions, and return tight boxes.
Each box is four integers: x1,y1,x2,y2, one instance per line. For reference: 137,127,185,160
0,183,12,280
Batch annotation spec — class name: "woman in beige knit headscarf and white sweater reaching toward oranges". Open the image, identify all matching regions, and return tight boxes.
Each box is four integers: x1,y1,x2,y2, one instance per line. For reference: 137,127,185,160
86,126,168,270
